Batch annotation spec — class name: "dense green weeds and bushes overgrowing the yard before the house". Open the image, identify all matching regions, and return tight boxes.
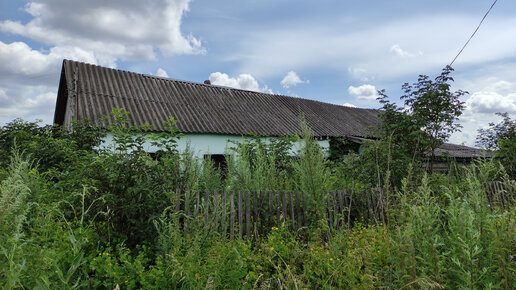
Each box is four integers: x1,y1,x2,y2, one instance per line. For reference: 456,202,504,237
0,68,516,289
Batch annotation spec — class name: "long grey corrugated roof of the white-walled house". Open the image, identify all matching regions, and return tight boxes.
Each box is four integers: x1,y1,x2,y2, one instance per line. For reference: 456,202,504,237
54,60,379,137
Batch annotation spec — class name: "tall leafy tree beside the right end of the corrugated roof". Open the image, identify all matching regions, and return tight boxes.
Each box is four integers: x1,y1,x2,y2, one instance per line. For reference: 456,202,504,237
378,66,468,171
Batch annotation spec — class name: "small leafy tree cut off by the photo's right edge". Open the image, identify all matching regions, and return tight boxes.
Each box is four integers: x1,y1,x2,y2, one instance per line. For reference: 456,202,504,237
476,112,516,178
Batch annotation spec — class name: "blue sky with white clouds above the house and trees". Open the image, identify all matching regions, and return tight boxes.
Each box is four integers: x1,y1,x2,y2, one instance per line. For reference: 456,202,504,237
0,0,516,145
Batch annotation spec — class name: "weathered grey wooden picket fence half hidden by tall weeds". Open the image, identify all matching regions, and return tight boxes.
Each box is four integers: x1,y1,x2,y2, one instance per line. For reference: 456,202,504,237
175,182,515,239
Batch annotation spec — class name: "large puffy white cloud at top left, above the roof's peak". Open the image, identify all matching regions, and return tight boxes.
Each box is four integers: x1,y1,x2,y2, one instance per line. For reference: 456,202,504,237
0,0,205,64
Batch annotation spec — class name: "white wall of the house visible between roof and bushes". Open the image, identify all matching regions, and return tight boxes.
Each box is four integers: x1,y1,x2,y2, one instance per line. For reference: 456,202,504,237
101,133,329,158
